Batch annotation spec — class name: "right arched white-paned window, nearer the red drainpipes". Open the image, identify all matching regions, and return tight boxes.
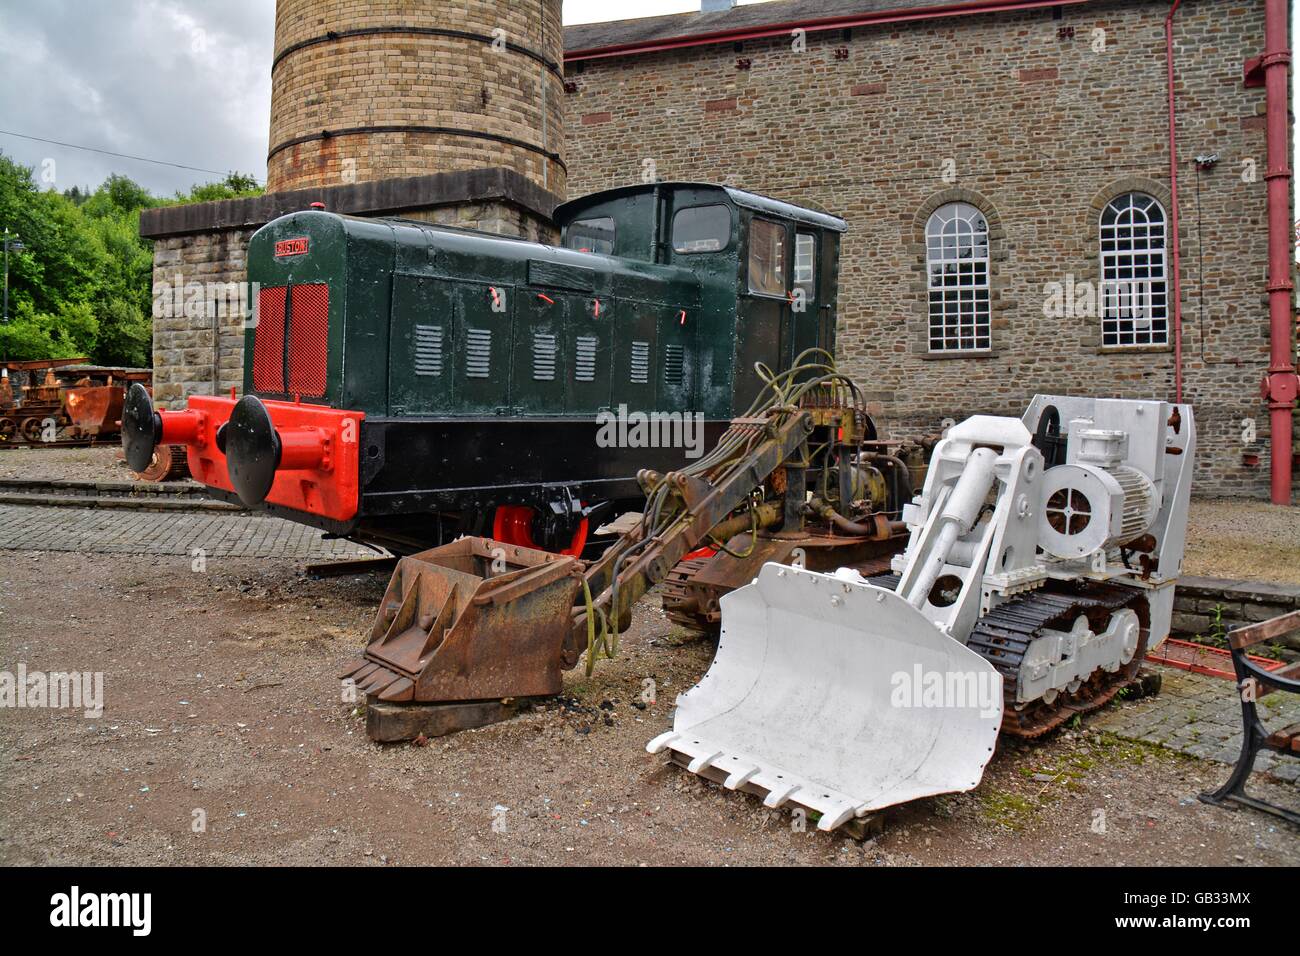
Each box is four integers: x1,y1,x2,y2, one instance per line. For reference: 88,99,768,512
1100,193,1169,347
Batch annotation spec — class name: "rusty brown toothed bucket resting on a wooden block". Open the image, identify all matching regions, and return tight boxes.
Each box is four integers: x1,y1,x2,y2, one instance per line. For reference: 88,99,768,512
342,537,582,736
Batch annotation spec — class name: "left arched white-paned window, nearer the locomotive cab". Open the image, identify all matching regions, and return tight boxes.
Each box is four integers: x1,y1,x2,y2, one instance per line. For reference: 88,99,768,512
926,203,989,352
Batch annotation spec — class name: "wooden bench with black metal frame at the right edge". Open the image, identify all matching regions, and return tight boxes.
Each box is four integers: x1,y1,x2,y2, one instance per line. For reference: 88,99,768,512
1201,611,1300,826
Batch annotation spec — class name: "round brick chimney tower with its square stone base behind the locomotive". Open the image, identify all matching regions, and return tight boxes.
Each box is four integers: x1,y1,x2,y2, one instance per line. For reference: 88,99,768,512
140,0,567,407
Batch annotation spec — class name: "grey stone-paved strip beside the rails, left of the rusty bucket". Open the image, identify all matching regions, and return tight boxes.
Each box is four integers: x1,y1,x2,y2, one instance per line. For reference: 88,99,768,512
0,505,374,561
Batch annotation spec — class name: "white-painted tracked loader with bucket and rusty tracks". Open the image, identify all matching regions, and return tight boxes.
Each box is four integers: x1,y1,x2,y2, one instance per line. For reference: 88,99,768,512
647,395,1195,830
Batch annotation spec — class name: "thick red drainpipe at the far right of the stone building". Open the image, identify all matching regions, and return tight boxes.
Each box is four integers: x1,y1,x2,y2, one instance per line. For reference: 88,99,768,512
1261,0,1297,505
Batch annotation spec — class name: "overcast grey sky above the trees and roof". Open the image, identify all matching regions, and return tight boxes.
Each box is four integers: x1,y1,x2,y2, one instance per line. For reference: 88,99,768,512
0,0,1300,194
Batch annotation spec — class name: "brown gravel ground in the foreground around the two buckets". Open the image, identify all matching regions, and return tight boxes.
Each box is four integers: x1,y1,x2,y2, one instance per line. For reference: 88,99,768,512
0,551,1300,865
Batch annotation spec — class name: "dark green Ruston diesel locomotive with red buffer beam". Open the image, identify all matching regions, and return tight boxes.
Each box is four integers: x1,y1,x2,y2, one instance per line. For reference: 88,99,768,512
124,182,845,554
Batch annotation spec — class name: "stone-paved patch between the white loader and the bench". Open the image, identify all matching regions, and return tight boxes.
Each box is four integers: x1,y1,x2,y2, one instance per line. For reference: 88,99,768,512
1088,665,1300,788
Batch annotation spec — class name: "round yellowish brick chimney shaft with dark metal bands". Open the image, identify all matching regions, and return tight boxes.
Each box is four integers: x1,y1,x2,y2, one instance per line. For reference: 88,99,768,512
267,0,566,196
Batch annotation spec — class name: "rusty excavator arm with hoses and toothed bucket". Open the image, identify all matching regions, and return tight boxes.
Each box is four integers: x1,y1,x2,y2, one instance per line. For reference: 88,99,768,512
342,364,898,740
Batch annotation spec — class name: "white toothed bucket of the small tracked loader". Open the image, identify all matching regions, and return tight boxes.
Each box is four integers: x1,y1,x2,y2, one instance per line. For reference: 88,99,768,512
646,564,1002,830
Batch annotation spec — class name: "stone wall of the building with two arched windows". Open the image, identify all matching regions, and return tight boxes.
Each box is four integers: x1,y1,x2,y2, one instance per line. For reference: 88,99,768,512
566,0,1284,496
